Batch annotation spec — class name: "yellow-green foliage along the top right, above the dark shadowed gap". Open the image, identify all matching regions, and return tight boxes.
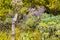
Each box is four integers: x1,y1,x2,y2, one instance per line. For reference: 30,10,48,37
23,0,60,15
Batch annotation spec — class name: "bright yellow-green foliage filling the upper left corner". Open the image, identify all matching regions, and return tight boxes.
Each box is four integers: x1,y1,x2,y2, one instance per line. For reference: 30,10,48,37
0,0,11,20
